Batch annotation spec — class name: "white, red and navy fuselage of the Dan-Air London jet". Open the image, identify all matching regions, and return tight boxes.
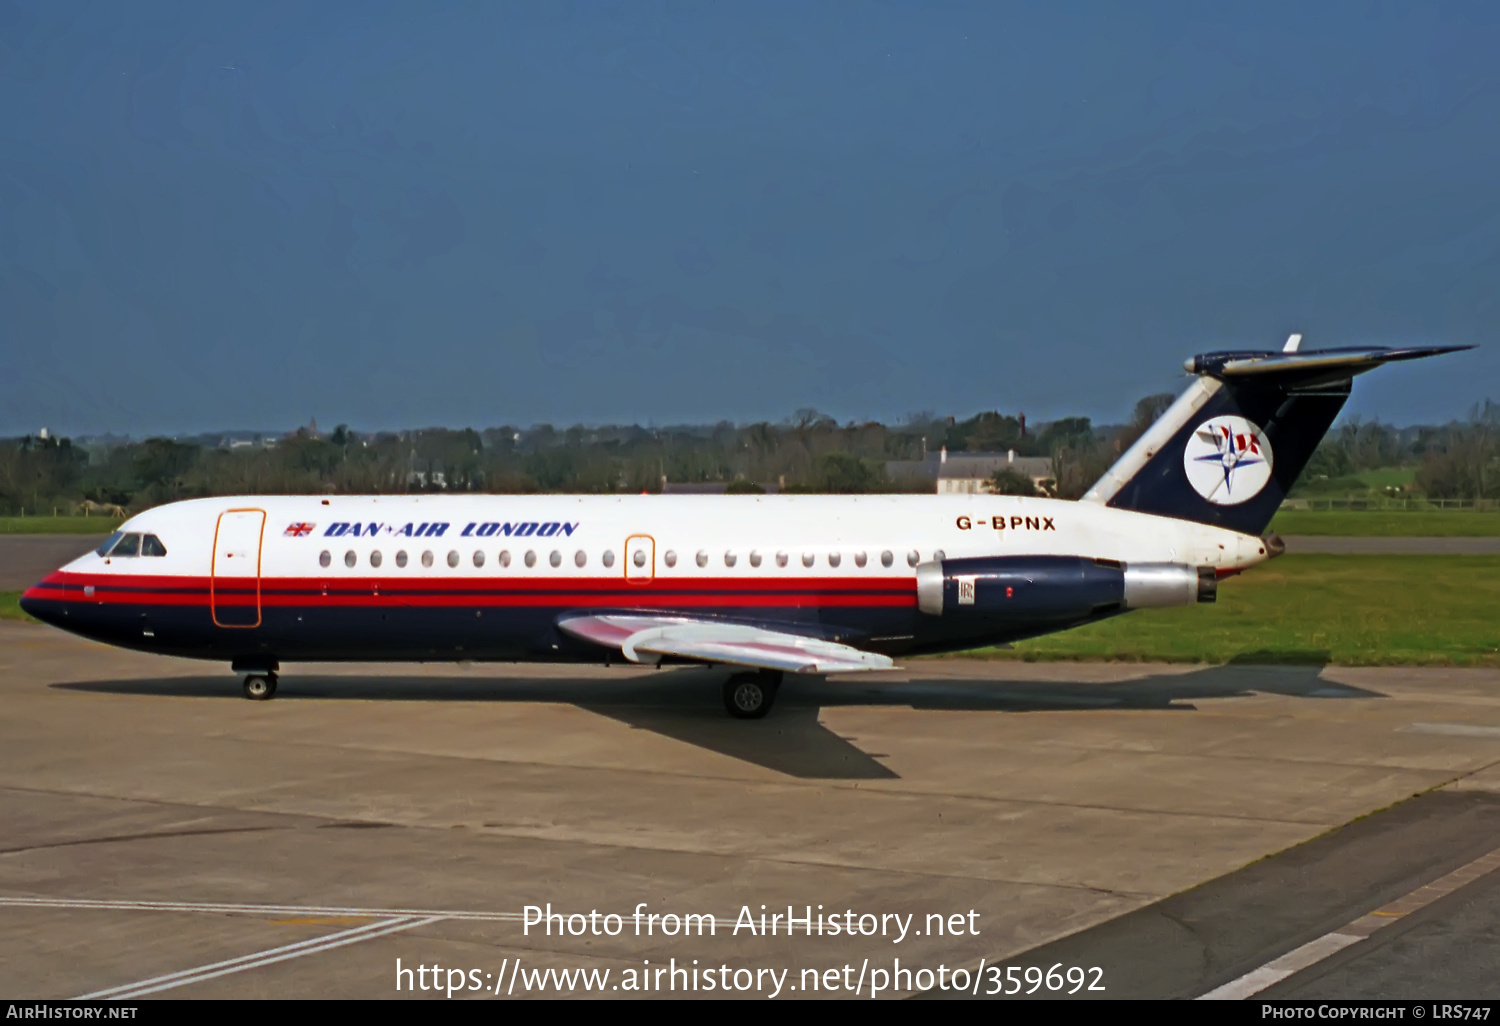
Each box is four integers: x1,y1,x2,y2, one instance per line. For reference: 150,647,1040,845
23,495,1268,665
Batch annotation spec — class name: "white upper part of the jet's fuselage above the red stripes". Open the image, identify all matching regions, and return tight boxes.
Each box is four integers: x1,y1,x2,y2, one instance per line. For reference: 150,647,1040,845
65,495,1266,581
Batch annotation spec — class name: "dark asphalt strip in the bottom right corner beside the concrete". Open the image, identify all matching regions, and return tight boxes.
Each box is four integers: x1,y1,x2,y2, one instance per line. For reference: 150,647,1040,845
930,786,1500,999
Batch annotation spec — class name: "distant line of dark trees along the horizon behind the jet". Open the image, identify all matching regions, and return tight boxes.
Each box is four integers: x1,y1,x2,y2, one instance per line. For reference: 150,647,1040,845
0,395,1500,515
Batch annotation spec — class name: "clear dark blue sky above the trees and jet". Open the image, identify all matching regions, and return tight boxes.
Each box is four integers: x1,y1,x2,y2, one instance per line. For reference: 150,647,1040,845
0,0,1500,437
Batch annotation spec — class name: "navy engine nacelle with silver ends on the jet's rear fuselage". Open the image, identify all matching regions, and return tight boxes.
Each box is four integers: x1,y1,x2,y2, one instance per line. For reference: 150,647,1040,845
917,555,1218,612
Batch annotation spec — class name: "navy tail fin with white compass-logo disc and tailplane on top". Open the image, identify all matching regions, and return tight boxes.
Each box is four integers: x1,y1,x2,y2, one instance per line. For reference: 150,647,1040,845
1083,336,1473,534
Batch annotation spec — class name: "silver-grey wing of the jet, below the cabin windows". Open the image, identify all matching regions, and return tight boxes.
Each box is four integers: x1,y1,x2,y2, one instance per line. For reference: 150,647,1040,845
558,614,896,674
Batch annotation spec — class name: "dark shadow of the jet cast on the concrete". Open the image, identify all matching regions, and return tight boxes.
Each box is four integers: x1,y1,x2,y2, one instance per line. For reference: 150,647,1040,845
51,651,1385,780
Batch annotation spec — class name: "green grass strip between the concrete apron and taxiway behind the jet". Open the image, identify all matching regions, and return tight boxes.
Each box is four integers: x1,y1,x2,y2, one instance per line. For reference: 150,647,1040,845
0,555,1500,666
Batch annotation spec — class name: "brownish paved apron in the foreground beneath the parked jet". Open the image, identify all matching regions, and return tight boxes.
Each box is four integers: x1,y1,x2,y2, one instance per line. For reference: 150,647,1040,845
0,623,1500,999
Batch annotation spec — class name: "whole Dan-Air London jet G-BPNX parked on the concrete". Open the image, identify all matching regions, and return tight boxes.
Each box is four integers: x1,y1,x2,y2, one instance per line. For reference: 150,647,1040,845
21,336,1473,719
